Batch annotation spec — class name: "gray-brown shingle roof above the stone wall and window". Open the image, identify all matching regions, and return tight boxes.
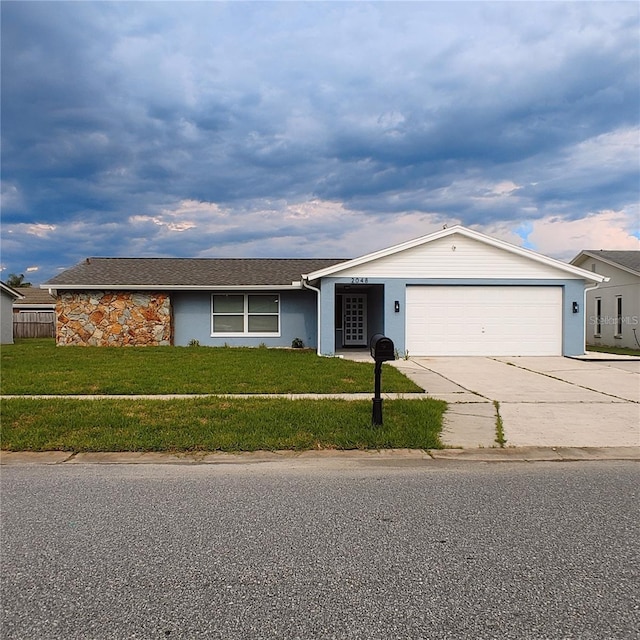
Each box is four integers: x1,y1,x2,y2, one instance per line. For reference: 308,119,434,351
44,258,345,289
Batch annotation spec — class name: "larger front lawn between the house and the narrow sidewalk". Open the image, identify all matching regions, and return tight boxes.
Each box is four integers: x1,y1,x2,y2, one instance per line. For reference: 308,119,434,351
0,339,422,395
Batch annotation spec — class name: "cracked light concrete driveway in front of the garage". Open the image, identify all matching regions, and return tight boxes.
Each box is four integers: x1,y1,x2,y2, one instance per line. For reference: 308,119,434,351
393,357,640,448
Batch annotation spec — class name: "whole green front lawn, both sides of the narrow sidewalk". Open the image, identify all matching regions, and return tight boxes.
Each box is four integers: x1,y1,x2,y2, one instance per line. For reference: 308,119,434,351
0,340,447,451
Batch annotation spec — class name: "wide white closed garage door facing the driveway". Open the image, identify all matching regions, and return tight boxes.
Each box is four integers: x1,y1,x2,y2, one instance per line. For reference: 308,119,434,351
406,286,562,356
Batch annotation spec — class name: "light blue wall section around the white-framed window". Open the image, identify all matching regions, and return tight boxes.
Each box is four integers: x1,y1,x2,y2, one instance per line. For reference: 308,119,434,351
171,291,317,349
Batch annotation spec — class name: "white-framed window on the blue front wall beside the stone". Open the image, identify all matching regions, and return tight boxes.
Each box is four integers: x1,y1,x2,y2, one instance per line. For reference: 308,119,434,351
211,293,280,336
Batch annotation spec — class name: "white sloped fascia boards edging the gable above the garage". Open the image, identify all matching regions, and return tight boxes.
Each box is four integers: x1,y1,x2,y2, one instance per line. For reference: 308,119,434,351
303,225,606,283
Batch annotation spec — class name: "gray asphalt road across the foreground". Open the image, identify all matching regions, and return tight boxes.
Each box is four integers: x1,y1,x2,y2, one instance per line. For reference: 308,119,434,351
1,461,640,640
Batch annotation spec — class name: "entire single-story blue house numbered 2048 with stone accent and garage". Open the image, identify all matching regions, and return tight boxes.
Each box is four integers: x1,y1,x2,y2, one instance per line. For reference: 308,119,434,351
42,226,605,355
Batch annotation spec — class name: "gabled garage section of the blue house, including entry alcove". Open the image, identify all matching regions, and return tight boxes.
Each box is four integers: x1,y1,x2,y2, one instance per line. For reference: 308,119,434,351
304,225,606,357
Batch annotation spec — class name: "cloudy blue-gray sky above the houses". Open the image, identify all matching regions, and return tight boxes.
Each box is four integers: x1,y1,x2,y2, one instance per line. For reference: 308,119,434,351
1,0,640,284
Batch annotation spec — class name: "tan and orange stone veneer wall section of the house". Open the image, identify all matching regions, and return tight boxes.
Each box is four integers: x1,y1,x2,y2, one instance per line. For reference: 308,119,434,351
56,291,172,347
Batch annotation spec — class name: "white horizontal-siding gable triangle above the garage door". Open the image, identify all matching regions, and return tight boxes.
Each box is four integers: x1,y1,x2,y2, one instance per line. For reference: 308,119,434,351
332,233,580,279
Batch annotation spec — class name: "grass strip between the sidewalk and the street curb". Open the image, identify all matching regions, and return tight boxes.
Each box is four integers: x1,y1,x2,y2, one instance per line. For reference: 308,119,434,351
1,397,447,452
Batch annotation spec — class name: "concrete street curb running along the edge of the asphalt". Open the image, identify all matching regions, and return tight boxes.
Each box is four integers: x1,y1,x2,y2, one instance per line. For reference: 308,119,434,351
0,446,640,466
